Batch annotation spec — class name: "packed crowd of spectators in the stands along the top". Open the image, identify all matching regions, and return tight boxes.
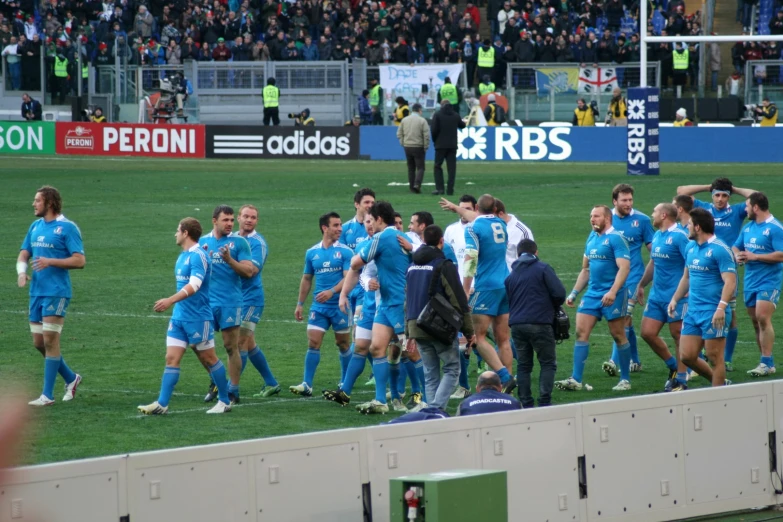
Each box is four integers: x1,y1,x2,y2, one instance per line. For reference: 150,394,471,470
0,0,720,90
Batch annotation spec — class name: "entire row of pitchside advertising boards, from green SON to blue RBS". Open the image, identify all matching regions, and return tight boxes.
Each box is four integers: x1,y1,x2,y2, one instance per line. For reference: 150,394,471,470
0,122,783,163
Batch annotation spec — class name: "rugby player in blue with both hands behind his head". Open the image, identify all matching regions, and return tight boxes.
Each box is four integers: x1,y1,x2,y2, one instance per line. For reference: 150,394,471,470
677,178,755,372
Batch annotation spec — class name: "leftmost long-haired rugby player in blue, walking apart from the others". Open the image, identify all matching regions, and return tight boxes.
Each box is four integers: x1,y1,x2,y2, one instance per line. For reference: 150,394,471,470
16,186,86,406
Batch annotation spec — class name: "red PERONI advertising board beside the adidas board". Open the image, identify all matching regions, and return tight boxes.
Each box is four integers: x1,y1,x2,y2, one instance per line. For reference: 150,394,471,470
56,122,204,158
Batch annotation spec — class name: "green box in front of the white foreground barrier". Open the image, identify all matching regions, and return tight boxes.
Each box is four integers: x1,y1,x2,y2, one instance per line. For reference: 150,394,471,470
389,470,508,522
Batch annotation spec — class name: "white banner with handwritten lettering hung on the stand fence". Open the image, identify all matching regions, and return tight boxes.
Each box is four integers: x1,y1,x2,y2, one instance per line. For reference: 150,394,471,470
378,63,462,103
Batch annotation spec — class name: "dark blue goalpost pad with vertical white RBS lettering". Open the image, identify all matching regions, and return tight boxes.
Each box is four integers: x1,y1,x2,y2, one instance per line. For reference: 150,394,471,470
627,87,661,176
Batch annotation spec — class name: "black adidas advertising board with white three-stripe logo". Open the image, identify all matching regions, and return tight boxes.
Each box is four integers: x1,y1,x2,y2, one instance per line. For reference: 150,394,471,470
206,125,359,160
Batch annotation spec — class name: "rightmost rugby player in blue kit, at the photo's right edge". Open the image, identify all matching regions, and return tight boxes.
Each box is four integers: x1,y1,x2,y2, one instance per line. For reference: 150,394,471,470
733,192,783,377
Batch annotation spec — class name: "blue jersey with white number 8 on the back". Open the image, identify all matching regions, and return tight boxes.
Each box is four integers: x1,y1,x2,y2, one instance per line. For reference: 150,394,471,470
465,214,508,291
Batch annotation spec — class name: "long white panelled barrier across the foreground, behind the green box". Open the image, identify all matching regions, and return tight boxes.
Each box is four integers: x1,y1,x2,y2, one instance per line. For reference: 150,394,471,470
0,381,783,522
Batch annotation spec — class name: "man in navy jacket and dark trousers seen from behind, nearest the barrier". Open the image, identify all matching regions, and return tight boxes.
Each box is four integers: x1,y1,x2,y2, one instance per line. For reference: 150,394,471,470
506,239,566,408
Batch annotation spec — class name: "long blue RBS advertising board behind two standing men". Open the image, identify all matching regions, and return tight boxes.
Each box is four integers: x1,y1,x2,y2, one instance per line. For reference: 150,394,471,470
359,127,783,163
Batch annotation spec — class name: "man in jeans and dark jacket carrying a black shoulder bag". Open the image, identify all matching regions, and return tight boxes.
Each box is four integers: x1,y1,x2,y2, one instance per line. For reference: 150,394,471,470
405,225,474,409
